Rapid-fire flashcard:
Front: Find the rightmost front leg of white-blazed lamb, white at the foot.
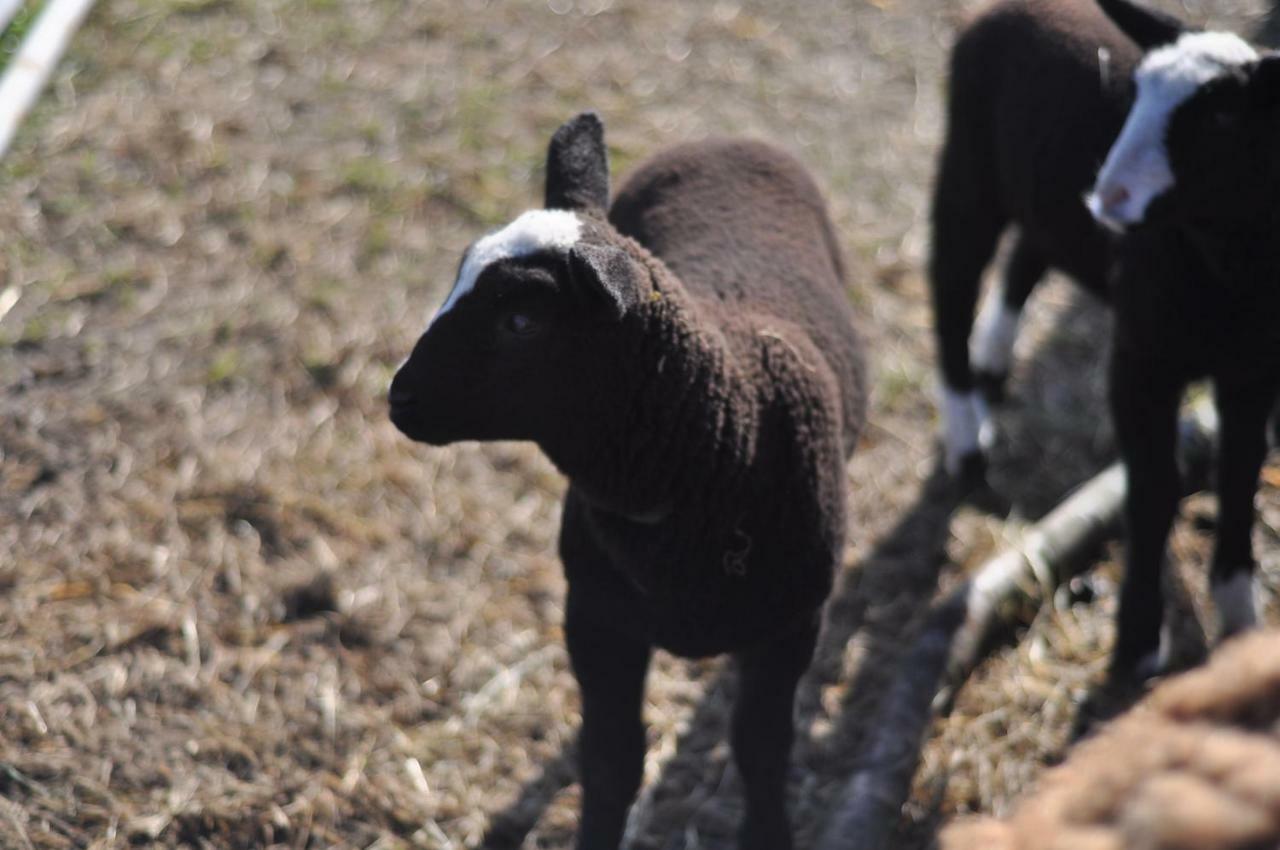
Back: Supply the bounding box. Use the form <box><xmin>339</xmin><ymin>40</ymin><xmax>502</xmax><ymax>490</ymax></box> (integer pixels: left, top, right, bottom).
<box><xmin>1210</xmin><ymin>381</ymin><xmax>1275</xmax><ymax>638</ymax></box>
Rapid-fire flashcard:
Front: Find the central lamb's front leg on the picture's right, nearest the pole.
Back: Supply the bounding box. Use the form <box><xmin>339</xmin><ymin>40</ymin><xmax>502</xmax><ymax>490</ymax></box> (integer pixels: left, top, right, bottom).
<box><xmin>732</xmin><ymin>614</ymin><xmax>818</xmax><ymax>850</ymax></box>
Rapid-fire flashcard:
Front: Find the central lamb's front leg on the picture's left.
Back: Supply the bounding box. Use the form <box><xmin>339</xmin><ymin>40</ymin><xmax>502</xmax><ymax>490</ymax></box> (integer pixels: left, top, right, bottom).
<box><xmin>564</xmin><ymin>596</ymin><xmax>652</xmax><ymax>850</ymax></box>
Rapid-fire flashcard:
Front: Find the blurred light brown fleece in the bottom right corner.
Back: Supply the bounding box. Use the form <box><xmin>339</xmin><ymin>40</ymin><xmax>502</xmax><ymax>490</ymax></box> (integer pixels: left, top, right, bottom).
<box><xmin>941</xmin><ymin>630</ymin><xmax>1280</xmax><ymax>850</ymax></box>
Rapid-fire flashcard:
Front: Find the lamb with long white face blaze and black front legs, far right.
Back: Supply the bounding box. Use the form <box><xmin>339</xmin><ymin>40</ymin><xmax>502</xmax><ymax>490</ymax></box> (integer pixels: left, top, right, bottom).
<box><xmin>1087</xmin><ymin>0</ymin><xmax>1280</xmax><ymax>675</ymax></box>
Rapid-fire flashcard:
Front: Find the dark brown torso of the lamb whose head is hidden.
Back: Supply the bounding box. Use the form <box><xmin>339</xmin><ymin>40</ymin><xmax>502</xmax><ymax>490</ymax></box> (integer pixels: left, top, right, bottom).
<box><xmin>934</xmin><ymin>0</ymin><xmax>1142</xmax><ymax>285</ymax></box>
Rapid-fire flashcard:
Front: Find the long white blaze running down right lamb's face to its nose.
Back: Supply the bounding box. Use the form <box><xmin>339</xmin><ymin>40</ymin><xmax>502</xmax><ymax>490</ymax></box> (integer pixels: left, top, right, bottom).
<box><xmin>1084</xmin><ymin>32</ymin><xmax>1258</xmax><ymax>232</ymax></box>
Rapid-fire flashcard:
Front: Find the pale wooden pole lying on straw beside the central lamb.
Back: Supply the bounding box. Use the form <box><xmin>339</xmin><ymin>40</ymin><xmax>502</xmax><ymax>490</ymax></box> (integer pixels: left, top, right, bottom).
<box><xmin>817</xmin><ymin>406</ymin><xmax>1216</xmax><ymax>850</ymax></box>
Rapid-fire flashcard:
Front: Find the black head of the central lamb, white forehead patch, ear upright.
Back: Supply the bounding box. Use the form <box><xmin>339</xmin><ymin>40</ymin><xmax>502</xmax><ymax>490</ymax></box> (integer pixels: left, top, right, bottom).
<box><xmin>389</xmin><ymin>114</ymin><xmax>652</xmax><ymax>445</ymax></box>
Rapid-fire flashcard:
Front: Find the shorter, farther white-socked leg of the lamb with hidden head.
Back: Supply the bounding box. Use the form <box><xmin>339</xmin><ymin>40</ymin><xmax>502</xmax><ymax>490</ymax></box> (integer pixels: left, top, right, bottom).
<box><xmin>969</xmin><ymin>232</ymin><xmax>1048</xmax><ymax>405</ymax></box>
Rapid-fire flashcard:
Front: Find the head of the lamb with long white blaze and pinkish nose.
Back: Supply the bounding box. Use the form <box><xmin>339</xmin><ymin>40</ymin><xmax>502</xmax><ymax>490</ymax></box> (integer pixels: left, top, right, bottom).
<box><xmin>1085</xmin><ymin>0</ymin><xmax>1280</xmax><ymax>232</ymax></box>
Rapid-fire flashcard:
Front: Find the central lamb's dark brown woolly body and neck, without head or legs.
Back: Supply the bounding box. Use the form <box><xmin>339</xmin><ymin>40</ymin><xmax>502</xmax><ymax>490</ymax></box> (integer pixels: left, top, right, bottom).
<box><xmin>563</xmin><ymin>141</ymin><xmax>867</xmax><ymax>655</ymax></box>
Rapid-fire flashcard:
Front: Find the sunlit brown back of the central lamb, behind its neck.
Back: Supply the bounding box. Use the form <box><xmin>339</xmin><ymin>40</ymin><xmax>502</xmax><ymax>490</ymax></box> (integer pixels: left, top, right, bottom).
<box><xmin>609</xmin><ymin>140</ymin><xmax>865</xmax><ymax>452</ymax></box>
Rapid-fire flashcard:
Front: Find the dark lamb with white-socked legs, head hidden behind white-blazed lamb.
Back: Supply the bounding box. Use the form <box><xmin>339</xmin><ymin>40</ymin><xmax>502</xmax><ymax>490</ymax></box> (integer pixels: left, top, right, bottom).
<box><xmin>929</xmin><ymin>0</ymin><xmax>1142</xmax><ymax>483</ymax></box>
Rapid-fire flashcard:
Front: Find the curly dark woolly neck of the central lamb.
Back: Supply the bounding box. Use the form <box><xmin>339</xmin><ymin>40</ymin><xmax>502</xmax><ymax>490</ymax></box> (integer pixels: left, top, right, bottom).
<box><xmin>548</xmin><ymin>268</ymin><xmax>758</xmax><ymax>522</ymax></box>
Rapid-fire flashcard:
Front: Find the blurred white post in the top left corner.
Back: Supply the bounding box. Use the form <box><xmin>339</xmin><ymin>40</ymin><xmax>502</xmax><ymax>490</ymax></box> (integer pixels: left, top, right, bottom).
<box><xmin>0</xmin><ymin>0</ymin><xmax>93</xmax><ymax>156</ymax></box>
